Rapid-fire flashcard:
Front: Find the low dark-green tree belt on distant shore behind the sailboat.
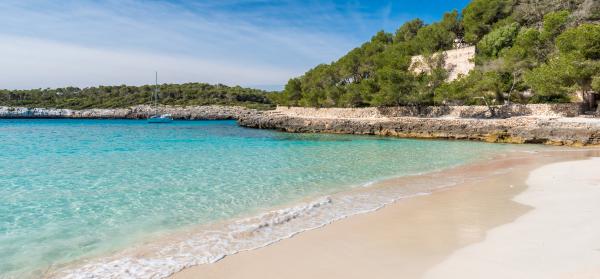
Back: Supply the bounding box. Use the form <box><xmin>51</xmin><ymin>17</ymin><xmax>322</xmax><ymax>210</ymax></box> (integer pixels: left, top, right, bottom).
<box><xmin>0</xmin><ymin>83</ymin><xmax>273</xmax><ymax>109</ymax></box>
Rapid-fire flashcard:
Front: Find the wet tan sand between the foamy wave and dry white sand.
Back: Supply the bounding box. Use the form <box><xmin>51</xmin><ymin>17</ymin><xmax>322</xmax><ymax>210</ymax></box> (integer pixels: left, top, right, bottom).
<box><xmin>170</xmin><ymin>149</ymin><xmax>600</xmax><ymax>279</ymax></box>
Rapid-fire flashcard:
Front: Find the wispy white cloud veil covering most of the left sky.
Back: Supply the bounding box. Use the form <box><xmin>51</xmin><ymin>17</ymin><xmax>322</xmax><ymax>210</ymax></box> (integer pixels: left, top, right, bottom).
<box><xmin>0</xmin><ymin>0</ymin><xmax>364</xmax><ymax>88</ymax></box>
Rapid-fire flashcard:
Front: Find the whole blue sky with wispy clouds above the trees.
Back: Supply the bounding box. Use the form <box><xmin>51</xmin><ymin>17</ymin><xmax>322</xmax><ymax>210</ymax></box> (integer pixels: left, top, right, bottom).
<box><xmin>0</xmin><ymin>0</ymin><xmax>469</xmax><ymax>90</ymax></box>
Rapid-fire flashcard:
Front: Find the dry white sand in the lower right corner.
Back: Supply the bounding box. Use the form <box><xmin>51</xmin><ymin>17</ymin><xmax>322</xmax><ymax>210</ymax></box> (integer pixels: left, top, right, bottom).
<box><xmin>425</xmin><ymin>158</ymin><xmax>600</xmax><ymax>278</ymax></box>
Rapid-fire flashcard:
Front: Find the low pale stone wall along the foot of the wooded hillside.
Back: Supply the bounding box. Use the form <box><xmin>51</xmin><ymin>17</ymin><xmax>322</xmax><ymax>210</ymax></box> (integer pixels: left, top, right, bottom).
<box><xmin>275</xmin><ymin>103</ymin><xmax>582</xmax><ymax>118</ymax></box>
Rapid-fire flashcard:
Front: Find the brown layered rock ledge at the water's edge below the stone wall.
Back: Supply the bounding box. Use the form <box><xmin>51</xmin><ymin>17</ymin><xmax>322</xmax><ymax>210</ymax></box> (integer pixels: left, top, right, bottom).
<box><xmin>238</xmin><ymin>112</ymin><xmax>600</xmax><ymax>146</ymax></box>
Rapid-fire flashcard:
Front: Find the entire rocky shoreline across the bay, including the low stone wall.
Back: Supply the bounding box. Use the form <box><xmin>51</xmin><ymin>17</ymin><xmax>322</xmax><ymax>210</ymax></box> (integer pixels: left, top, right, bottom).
<box><xmin>0</xmin><ymin>105</ymin><xmax>600</xmax><ymax>146</ymax></box>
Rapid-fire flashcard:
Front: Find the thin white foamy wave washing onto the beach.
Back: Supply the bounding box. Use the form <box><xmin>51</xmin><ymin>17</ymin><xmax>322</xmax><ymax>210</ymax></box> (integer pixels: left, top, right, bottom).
<box><xmin>48</xmin><ymin>174</ymin><xmax>455</xmax><ymax>279</ymax></box>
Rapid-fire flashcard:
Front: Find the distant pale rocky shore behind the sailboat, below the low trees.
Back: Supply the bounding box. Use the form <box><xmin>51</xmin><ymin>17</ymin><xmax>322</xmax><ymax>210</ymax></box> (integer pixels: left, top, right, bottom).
<box><xmin>0</xmin><ymin>105</ymin><xmax>257</xmax><ymax>120</ymax></box>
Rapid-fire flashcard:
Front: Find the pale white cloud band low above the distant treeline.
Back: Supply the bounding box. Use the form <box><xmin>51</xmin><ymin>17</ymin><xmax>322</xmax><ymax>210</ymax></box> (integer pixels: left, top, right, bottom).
<box><xmin>0</xmin><ymin>36</ymin><xmax>299</xmax><ymax>88</ymax></box>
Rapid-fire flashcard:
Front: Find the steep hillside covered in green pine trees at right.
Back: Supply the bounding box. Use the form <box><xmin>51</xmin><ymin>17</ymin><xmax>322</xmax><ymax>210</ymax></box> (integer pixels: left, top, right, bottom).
<box><xmin>276</xmin><ymin>0</ymin><xmax>600</xmax><ymax>109</ymax></box>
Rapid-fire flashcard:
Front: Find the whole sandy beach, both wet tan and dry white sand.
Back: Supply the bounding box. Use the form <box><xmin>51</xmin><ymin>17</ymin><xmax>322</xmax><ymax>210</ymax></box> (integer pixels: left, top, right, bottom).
<box><xmin>172</xmin><ymin>150</ymin><xmax>600</xmax><ymax>279</ymax></box>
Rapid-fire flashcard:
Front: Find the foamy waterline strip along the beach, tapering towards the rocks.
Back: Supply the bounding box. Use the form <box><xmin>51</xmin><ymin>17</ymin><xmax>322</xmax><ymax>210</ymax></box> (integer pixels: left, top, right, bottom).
<box><xmin>45</xmin><ymin>148</ymin><xmax>510</xmax><ymax>278</ymax></box>
